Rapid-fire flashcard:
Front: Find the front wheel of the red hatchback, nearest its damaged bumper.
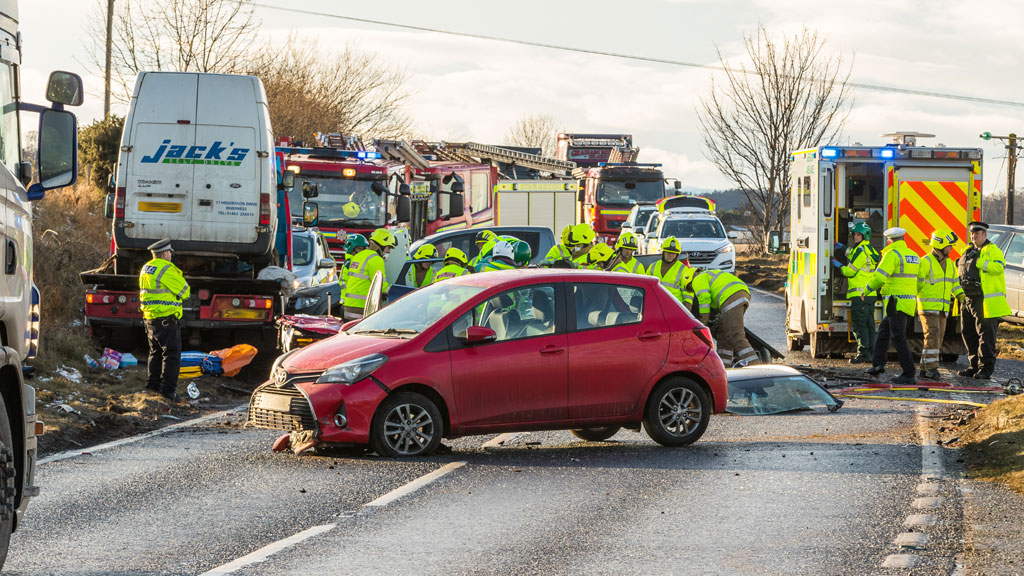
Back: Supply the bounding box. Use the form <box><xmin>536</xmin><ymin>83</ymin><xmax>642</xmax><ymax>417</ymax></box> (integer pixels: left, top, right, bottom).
<box><xmin>370</xmin><ymin>392</ymin><xmax>444</xmax><ymax>457</ymax></box>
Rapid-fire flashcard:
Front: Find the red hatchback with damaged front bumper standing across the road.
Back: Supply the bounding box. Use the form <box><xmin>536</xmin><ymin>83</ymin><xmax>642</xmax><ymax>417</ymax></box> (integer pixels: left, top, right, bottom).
<box><xmin>249</xmin><ymin>270</ymin><xmax>728</xmax><ymax>456</ymax></box>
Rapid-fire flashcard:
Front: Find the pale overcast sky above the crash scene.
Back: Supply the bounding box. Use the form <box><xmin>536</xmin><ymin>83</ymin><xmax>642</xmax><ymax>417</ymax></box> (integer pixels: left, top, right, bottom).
<box><xmin>20</xmin><ymin>0</ymin><xmax>1024</xmax><ymax>193</ymax></box>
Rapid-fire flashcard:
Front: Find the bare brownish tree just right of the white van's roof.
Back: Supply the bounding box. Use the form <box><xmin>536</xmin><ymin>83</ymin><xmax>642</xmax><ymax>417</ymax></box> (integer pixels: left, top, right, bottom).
<box><xmin>254</xmin><ymin>35</ymin><xmax>411</xmax><ymax>141</ymax></box>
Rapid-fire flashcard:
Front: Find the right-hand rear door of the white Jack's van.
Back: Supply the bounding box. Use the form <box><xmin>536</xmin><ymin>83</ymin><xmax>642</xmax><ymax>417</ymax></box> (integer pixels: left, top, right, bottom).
<box><xmin>191</xmin><ymin>76</ymin><xmax>261</xmax><ymax>244</ymax></box>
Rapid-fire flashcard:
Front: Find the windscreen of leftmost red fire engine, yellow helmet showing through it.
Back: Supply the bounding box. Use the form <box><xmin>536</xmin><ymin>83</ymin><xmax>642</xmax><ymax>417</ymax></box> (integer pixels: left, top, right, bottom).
<box><xmin>288</xmin><ymin>175</ymin><xmax>387</xmax><ymax>227</ymax></box>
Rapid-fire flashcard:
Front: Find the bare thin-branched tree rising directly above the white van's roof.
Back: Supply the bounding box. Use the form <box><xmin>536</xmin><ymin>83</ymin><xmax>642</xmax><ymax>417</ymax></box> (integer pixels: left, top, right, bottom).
<box><xmin>88</xmin><ymin>0</ymin><xmax>259</xmax><ymax>101</ymax></box>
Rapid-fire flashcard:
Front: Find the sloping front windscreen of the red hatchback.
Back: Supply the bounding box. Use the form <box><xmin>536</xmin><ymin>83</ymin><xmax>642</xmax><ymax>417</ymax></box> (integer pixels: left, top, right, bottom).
<box><xmin>349</xmin><ymin>280</ymin><xmax>483</xmax><ymax>336</ymax></box>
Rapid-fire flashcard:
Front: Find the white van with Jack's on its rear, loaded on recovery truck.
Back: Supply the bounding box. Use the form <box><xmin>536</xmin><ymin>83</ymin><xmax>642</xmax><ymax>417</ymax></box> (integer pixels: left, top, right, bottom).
<box><xmin>114</xmin><ymin>72</ymin><xmax>278</xmax><ymax>265</ymax></box>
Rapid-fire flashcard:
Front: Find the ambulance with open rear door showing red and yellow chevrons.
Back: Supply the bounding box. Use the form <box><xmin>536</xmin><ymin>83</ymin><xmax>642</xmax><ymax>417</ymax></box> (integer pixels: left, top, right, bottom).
<box><xmin>768</xmin><ymin>132</ymin><xmax>982</xmax><ymax>361</ymax></box>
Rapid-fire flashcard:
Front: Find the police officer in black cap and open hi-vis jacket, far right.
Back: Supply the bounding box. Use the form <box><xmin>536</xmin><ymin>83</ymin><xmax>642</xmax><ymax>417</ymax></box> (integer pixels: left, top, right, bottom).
<box><xmin>957</xmin><ymin>221</ymin><xmax>1013</xmax><ymax>379</ymax></box>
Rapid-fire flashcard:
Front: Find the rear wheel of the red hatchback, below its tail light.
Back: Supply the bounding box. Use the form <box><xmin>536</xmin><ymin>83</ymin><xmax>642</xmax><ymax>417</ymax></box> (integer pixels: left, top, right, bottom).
<box><xmin>643</xmin><ymin>376</ymin><xmax>712</xmax><ymax>446</ymax></box>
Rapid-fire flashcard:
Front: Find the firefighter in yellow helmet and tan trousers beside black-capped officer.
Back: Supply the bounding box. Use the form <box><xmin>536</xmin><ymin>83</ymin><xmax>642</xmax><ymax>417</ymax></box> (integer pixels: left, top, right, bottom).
<box><xmin>918</xmin><ymin>228</ymin><xmax>964</xmax><ymax>380</ymax></box>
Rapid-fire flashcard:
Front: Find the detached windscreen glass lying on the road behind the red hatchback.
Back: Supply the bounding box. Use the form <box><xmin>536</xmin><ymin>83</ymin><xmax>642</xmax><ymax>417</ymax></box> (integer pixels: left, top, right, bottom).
<box><xmin>725</xmin><ymin>374</ymin><xmax>843</xmax><ymax>415</ymax></box>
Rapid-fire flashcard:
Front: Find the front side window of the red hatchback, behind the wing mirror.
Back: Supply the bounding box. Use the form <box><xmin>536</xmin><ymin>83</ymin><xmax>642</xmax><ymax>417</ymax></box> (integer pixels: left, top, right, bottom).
<box><xmin>452</xmin><ymin>284</ymin><xmax>555</xmax><ymax>342</ymax></box>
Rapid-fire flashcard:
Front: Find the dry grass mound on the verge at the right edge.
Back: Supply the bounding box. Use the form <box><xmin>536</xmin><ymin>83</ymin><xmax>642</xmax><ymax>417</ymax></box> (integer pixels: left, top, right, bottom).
<box><xmin>961</xmin><ymin>396</ymin><xmax>1024</xmax><ymax>494</ymax></box>
